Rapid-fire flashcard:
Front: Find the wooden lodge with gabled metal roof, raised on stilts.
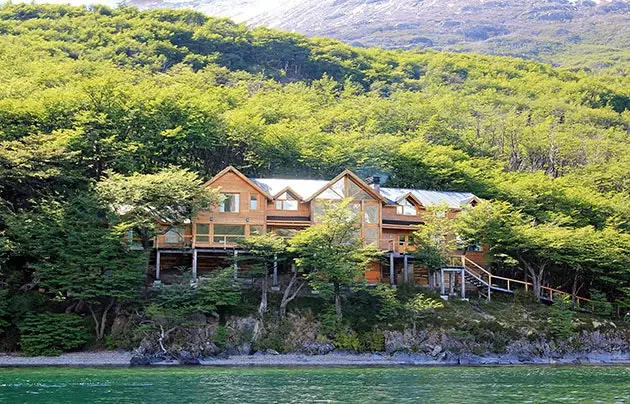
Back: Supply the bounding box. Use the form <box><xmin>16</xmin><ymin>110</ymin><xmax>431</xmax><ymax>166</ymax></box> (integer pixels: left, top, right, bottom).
<box><xmin>152</xmin><ymin>167</ymin><xmax>486</xmax><ymax>286</ymax></box>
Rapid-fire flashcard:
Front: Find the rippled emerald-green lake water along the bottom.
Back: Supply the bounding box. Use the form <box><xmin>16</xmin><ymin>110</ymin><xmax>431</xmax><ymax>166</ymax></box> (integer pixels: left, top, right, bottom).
<box><xmin>0</xmin><ymin>366</ymin><xmax>630</xmax><ymax>404</ymax></box>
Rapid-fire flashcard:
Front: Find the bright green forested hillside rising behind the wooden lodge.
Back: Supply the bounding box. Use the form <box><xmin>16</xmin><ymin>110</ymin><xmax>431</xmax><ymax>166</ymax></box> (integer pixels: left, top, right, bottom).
<box><xmin>0</xmin><ymin>5</ymin><xmax>630</xmax><ymax>350</ymax></box>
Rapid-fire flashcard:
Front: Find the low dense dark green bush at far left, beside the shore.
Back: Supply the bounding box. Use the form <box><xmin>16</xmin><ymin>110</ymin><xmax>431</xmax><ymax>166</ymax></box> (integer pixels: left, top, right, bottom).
<box><xmin>19</xmin><ymin>313</ymin><xmax>90</xmax><ymax>356</ymax></box>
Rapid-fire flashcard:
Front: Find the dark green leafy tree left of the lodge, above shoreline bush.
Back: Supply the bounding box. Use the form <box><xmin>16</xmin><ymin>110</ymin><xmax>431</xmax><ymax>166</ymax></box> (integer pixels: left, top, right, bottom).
<box><xmin>8</xmin><ymin>194</ymin><xmax>147</xmax><ymax>339</ymax></box>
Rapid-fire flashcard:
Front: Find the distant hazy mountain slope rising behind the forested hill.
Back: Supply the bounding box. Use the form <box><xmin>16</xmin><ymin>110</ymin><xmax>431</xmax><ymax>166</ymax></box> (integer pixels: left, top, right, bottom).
<box><xmin>130</xmin><ymin>0</ymin><xmax>630</xmax><ymax>67</ymax></box>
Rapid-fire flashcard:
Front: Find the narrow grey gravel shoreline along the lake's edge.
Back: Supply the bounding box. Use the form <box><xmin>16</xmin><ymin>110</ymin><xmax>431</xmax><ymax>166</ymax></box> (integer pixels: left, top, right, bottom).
<box><xmin>0</xmin><ymin>351</ymin><xmax>630</xmax><ymax>368</ymax></box>
